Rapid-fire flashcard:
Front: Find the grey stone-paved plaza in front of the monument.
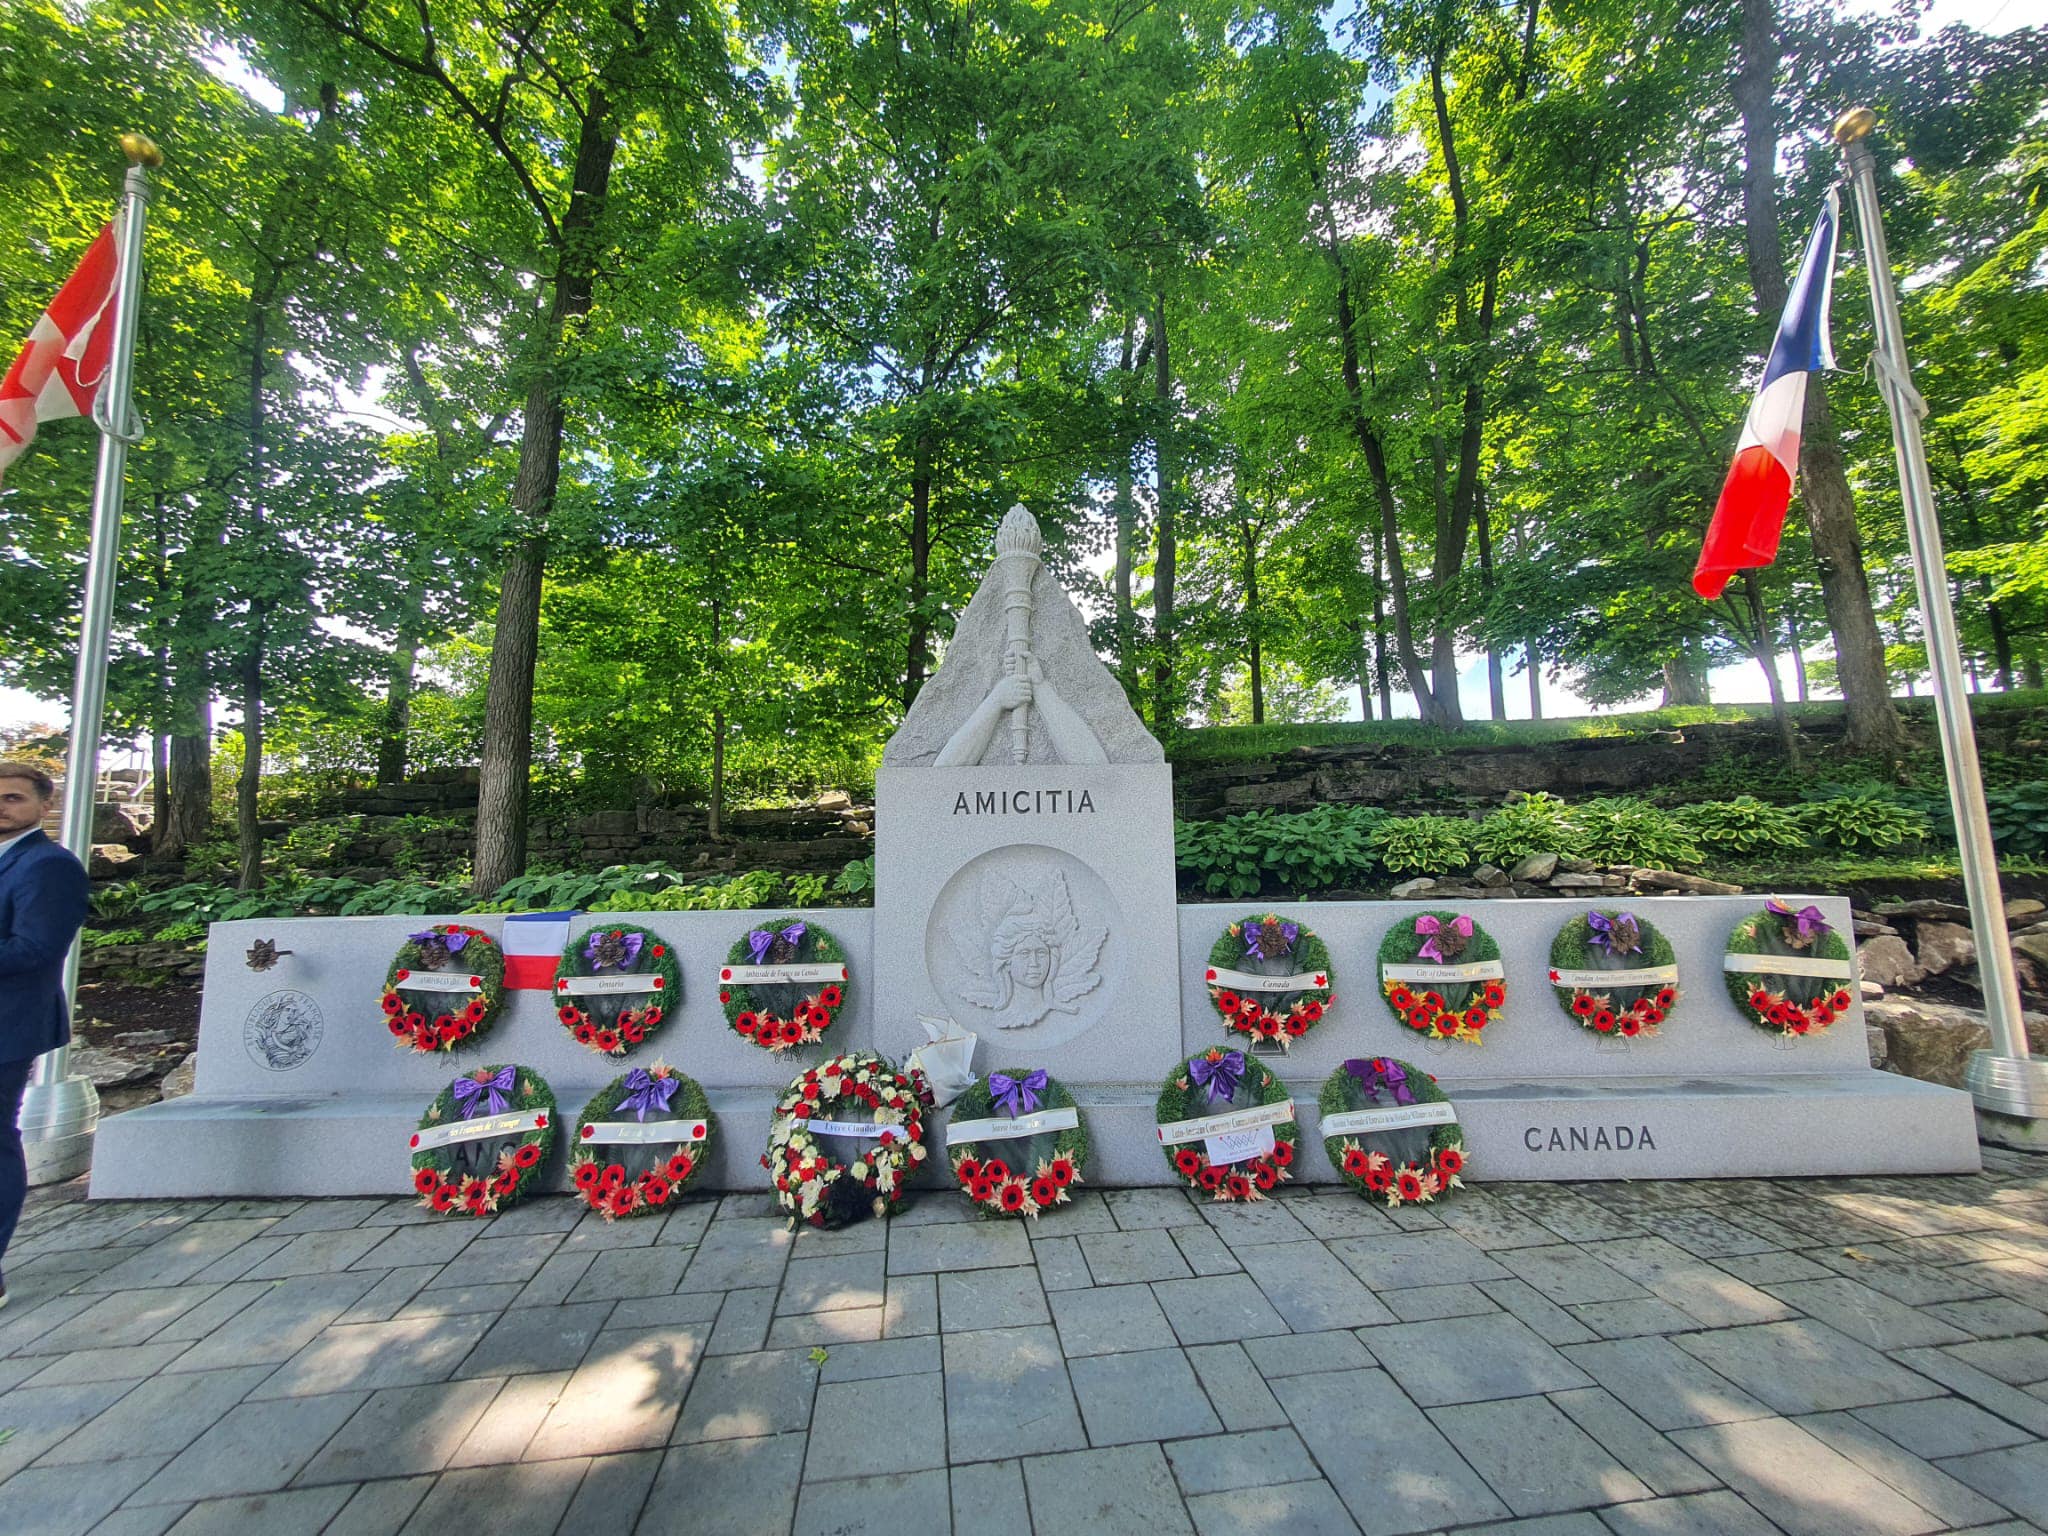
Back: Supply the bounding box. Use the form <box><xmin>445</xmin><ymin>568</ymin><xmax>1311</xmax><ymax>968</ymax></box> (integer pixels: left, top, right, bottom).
<box><xmin>0</xmin><ymin>1149</ymin><xmax>2048</xmax><ymax>1536</ymax></box>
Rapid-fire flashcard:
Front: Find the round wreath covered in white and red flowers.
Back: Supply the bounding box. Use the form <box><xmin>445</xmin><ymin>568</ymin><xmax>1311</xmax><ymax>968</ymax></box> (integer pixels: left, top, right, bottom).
<box><xmin>762</xmin><ymin>1051</ymin><xmax>926</xmax><ymax>1227</ymax></box>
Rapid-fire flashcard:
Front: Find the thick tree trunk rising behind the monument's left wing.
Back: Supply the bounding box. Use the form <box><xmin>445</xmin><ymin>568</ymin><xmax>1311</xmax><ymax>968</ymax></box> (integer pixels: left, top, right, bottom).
<box><xmin>471</xmin><ymin>108</ymin><xmax>618</xmax><ymax>897</ymax></box>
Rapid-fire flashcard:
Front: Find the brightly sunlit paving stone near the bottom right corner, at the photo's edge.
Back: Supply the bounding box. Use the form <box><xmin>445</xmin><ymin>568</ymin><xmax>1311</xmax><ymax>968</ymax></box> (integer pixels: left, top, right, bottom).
<box><xmin>1671</xmin><ymin>1419</ymin><xmax>1944</xmax><ymax>1536</ymax></box>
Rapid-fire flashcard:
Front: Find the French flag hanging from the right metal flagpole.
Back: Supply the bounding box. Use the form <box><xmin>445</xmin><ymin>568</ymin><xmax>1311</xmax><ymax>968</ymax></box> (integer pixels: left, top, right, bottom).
<box><xmin>1692</xmin><ymin>190</ymin><xmax>1841</xmax><ymax>602</ymax></box>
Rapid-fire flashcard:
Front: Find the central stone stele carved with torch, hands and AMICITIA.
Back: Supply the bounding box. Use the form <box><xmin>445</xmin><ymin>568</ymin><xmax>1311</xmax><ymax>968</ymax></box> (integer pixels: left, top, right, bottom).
<box><xmin>872</xmin><ymin>506</ymin><xmax>1180</xmax><ymax>1083</ymax></box>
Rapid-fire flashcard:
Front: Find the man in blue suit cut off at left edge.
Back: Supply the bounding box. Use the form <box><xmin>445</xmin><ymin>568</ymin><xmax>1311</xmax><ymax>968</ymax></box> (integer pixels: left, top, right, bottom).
<box><xmin>0</xmin><ymin>762</ymin><xmax>90</xmax><ymax>1307</ymax></box>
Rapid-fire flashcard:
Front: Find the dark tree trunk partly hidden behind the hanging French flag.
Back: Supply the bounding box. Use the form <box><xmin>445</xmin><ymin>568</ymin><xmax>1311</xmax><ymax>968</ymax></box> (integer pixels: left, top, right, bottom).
<box><xmin>1735</xmin><ymin>0</ymin><xmax>1907</xmax><ymax>760</ymax></box>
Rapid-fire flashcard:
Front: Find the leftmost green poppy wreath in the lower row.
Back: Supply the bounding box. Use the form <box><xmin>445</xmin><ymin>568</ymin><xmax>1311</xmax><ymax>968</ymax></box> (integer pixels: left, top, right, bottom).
<box><xmin>412</xmin><ymin>1063</ymin><xmax>555</xmax><ymax>1217</ymax></box>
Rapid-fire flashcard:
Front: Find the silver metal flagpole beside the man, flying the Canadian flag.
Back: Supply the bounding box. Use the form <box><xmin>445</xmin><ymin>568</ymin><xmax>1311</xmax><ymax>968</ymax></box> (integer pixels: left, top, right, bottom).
<box><xmin>20</xmin><ymin>133</ymin><xmax>164</xmax><ymax>1184</ymax></box>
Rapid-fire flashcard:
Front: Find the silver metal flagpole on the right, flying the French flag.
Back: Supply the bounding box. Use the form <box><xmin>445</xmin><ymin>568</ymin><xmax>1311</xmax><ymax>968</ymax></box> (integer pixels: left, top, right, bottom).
<box><xmin>1835</xmin><ymin>106</ymin><xmax>2048</xmax><ymax>1145</ymax></box>
